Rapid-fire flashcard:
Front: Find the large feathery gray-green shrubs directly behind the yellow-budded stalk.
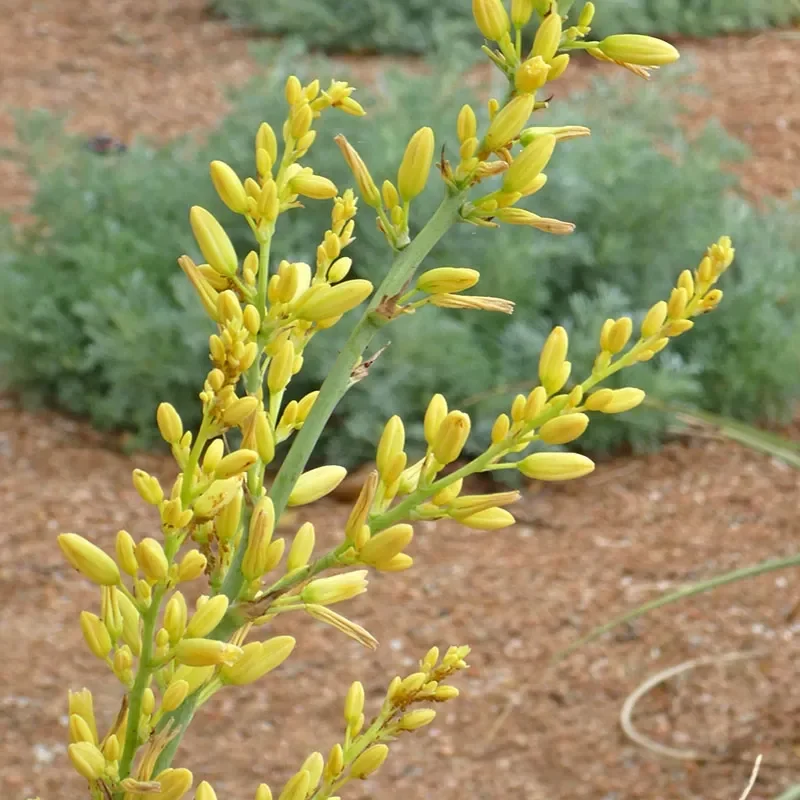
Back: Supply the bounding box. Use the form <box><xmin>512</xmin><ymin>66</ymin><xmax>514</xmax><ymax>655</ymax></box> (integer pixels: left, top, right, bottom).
<box><xmin>0</xmin><ymin>47</ymin><xmax>800</xmax><ymax>463</ymax></box>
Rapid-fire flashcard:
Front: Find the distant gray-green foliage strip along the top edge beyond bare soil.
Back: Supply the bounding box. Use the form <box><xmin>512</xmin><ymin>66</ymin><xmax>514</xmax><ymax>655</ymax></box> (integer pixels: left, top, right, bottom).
<box><xmin>212</xmin><ymin>0</ymin><xmax>800</xmax><ymax>53</ymax></box>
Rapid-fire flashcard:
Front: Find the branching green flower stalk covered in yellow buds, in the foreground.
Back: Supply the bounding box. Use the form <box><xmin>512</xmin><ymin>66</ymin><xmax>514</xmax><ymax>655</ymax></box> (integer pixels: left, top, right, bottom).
<box><xmin>39</xmin><ymin>0</ymin><xmax>733</xmax><ymax>800</ymax></box>
